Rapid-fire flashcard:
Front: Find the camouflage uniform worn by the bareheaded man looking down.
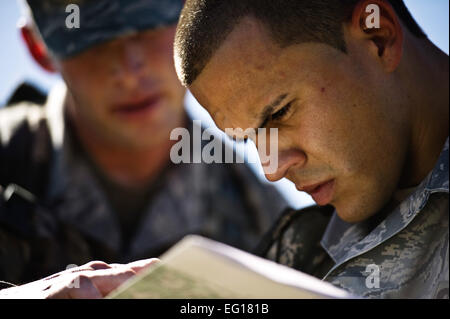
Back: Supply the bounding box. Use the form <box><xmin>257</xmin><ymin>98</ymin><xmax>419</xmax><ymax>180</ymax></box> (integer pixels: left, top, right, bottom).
<box><xmin>258</xmin><ymin>139</ymin><xmax>449</xmax><ymax>298</ymax></box>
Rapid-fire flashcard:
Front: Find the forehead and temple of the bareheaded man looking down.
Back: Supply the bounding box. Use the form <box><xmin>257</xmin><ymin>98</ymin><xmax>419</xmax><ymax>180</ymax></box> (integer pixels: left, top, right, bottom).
<box><xmin>191</xmin><ymin>18</ymin><xmax>346</xmax><ymax>134</ymax></box>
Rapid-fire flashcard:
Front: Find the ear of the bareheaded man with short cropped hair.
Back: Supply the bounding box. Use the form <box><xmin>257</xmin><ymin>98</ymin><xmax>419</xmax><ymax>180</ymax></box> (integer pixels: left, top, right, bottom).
<box><xmin>350</xmin><ymin>0</ymin><xmax>403</xmax><ymax>72</ymax></box>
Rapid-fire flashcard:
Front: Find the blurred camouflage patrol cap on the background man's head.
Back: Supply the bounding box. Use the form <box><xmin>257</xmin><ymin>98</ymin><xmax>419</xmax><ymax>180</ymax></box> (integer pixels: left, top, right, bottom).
<box><xmin>26</xmin><ymin>0</ymin><xmax>184</xmax><ymax>59</ymax></box>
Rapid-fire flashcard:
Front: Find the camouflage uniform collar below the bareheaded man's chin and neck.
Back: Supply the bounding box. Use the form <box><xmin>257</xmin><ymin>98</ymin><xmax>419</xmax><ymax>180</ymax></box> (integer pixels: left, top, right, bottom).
<box><xmin>321</xmin><ymin>138</ymin><xmax>449</xmax><ymax>268</ymax></box>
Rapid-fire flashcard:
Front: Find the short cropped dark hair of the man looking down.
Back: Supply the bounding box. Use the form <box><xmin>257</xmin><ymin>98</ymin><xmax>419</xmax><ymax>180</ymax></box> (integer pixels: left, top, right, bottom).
<box><xmin>175</xmin><ymin>0</ymin><xmax>426</xmax><ymax>86</ymax></box>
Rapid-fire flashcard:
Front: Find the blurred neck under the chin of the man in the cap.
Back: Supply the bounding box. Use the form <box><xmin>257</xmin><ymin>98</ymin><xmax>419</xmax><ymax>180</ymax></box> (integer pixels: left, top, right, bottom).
<box><xmin>66</xmin><ymin>97</ymin><xmax>184</xmax><ymax>188</ymax></box>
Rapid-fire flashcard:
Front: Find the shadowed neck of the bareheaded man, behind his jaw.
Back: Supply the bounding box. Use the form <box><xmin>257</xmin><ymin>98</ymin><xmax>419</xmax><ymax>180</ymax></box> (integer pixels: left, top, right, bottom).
<box><xmin>399</xmin><ymin>38</ymin><xmax>449</xmax><ymax>188</ymax></box>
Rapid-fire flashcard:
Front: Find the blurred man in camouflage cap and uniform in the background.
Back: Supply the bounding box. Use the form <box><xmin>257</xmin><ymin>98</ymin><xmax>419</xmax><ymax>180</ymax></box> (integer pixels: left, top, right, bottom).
<box><xmin>0</xmin><ymin>0</ymin><xmax>285</xmax><ymax>298</ymax></box>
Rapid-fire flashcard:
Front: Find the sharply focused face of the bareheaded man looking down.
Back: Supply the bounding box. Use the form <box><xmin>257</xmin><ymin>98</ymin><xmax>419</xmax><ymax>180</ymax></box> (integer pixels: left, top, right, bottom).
<box><xmin>190</xmin><ymin>19</ymin><xmax>407</xmax><ymax>222</ymax></box>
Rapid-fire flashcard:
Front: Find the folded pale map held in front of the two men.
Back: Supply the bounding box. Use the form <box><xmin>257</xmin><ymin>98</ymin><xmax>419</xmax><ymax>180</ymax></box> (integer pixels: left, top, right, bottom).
<box><xmin>107</xmin><ymin>235</ymin><xmax>352</xmax><ymax>299</ymax></box>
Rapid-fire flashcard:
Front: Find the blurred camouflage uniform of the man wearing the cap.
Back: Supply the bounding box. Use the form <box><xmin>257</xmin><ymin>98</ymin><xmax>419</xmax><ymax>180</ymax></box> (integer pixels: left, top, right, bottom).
<box><xmin>0</xmin><ymin>85</ymin><xmax>286</xmax><ymax>283</ymax></box>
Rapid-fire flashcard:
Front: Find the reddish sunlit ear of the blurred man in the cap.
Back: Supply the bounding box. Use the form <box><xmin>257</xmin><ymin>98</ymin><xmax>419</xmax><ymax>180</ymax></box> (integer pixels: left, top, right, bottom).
<box><xmin>19</xmin><ymin>24</ymin><xmax>56</xmax><ymax>73</ymax></box>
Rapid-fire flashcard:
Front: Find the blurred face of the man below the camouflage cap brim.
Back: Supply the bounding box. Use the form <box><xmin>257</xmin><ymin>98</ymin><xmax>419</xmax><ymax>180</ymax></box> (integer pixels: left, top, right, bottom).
<box><xmin>57</xmin><ymin>26</ymin><xmax>185</xmax><ymax>147</ymax></box>
